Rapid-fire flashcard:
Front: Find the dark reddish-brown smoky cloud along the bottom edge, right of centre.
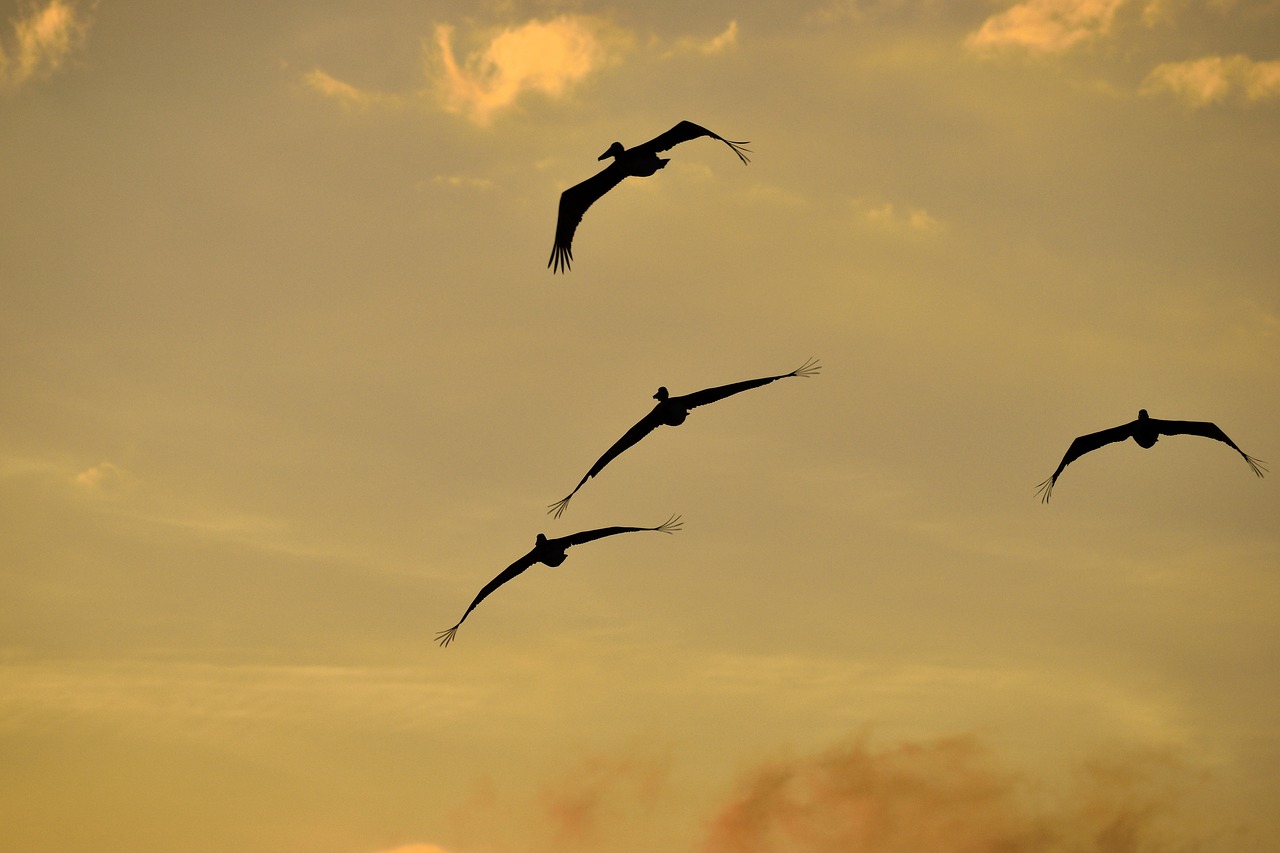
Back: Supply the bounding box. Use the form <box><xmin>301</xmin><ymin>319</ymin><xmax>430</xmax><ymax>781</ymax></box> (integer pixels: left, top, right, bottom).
<box><xmin>703</xmin><ymin>738</ymin><xmax>1194</xmax><ymax>853</ymax></box>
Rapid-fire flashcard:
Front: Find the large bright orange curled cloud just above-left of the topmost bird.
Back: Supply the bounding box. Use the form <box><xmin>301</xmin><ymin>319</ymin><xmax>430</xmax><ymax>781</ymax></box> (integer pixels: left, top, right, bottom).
<box><xmin>435</xmin><ymin>15</ymin><xmax>608</xmax><ymax>124</ymax></box>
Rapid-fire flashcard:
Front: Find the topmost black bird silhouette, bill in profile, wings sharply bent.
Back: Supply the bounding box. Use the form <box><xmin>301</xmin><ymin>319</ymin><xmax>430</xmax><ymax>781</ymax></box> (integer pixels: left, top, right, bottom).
<box><xmin>547</xmin><ymin>122</ymin><xmax>750</xmax><ymax>273</ymax></box>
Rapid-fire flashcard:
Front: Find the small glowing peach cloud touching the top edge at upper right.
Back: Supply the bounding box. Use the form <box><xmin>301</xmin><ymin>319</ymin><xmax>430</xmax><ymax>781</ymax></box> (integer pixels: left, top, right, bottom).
<box><xmin>965</xmin><ymin>0</ymin><xmax>1125</xmax><ymax>54</ymax></box>
